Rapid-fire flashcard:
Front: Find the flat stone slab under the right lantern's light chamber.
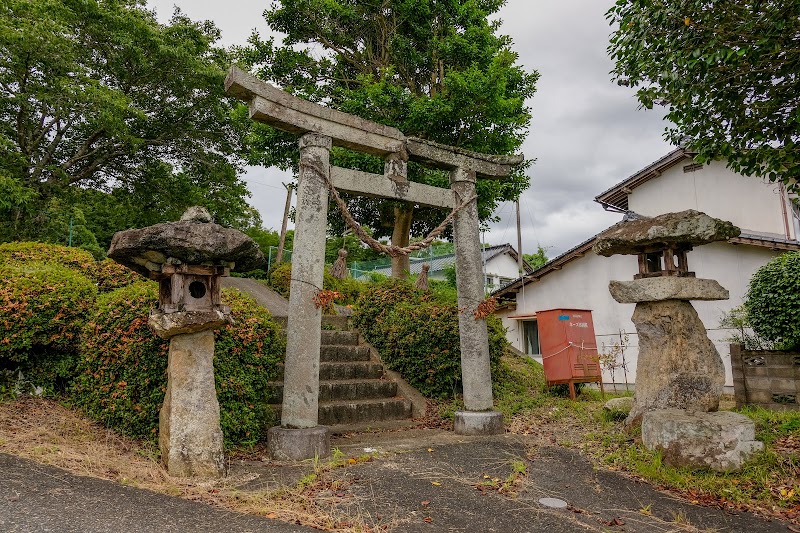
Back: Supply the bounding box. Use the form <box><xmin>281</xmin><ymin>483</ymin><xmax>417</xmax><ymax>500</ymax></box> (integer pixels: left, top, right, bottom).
<box><xmin>608</xmin><ymin>276</ymin><xmax>730</xmax><ymax>304</ymax></box>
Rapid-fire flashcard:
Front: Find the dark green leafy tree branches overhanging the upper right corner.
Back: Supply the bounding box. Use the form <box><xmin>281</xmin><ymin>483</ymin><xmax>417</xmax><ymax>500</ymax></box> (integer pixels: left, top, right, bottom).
<box><xmin>607</xmin><ymin>0</ymin><xmax>800</xmax><ymax>190</ymax></box>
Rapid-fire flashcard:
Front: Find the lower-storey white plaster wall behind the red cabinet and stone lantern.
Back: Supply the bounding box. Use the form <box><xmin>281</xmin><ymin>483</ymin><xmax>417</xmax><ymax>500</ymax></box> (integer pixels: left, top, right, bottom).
<box><xmin>510</xmin><ymin>243</ymin><xmax>777</xmax><ymax>386</ymax></box>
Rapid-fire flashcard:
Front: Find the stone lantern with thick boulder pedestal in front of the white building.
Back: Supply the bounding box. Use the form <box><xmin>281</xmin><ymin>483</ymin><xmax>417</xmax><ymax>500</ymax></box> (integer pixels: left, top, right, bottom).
<box><xmin>594</xmin><ymin>210</ymin><xmax>740</xmax><ymax>423</ymax></box>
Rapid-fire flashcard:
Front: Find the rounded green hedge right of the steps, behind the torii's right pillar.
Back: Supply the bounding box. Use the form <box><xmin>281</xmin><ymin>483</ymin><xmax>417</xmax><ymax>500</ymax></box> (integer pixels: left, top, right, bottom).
<box><xmin>353</xmin><ymin>279</ymin><xmax>508</xmax><ymax>398</ymax></box>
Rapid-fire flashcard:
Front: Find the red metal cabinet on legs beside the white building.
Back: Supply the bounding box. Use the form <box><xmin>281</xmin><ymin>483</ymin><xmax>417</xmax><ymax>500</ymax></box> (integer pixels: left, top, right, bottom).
<box><xmin>536</xmin><ymin>309</ymin><xmax>603</xmax><ymax>398</ymax></box>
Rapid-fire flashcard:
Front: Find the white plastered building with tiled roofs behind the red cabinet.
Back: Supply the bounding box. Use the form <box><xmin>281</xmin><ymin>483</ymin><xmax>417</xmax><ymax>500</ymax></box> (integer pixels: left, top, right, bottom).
<box><xmin>494</xmin><ymin>148</ymin><xmax>800</xmax><ymax>385</ymax></box>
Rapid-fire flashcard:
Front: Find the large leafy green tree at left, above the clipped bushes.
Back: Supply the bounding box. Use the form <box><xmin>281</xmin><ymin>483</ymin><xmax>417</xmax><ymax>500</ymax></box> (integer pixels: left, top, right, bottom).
<box><xmin>0</xmin><ymin>0</ymin><xmax>257</xmax><ymax>244</ymax></box>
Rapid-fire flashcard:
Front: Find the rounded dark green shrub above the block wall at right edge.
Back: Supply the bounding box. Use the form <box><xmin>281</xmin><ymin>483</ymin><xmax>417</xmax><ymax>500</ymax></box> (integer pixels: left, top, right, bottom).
<box><xmin>744</xmin><ymin>252</ymin><xmax>800</xmax><ymax>350</ymax></box>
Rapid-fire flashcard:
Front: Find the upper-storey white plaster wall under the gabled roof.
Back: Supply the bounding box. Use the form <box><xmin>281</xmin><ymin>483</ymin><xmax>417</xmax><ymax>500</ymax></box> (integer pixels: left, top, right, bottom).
<box><xmin>628</xmin><ymin>159</ymin><xmax>797</xmax><ymax>239</ymax></box>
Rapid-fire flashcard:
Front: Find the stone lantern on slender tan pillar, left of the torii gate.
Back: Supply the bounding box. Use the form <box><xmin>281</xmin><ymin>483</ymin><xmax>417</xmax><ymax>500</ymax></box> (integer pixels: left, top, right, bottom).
<box><xmin>108</xmin><ymin>207</ymin><xmax>264</xmax><ymax>477</ymax></box>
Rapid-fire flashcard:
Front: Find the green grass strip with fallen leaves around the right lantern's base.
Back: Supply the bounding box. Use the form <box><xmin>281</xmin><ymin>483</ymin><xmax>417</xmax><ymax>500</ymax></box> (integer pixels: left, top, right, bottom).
<box><xmin>496</xmin><ymin>390</ymin><xmax>800</xmax><ymax>523</ymax></box>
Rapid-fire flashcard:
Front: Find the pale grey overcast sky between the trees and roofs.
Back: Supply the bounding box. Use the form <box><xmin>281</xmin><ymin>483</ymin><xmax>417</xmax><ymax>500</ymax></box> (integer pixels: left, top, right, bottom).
<box><xmin>148</xmin><ymin>0</ymin><xmax>672</xmax><ymax>258</ymax></box>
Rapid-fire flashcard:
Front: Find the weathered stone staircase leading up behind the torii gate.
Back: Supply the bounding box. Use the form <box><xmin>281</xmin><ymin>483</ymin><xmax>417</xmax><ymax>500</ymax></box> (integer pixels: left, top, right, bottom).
<box><xmin>268</xmin><ymin>330</ymin><xmax>424</xmax><ymax>433</ymax></box>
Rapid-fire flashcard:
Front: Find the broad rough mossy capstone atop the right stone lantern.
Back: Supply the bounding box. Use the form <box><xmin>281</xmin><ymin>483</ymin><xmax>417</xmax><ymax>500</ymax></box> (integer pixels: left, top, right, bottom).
<box><xmin>592</xmin><ymin>209</ymin><xmax>741</xmax><ymax>257</ymax></box>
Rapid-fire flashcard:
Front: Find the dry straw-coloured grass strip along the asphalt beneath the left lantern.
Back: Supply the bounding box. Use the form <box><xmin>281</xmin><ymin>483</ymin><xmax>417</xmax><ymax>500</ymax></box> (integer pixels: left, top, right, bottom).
<box><xmin>0</xmin><ymin>398</ymin><xmax>382</xmax><ymax>533</ymax></box>
